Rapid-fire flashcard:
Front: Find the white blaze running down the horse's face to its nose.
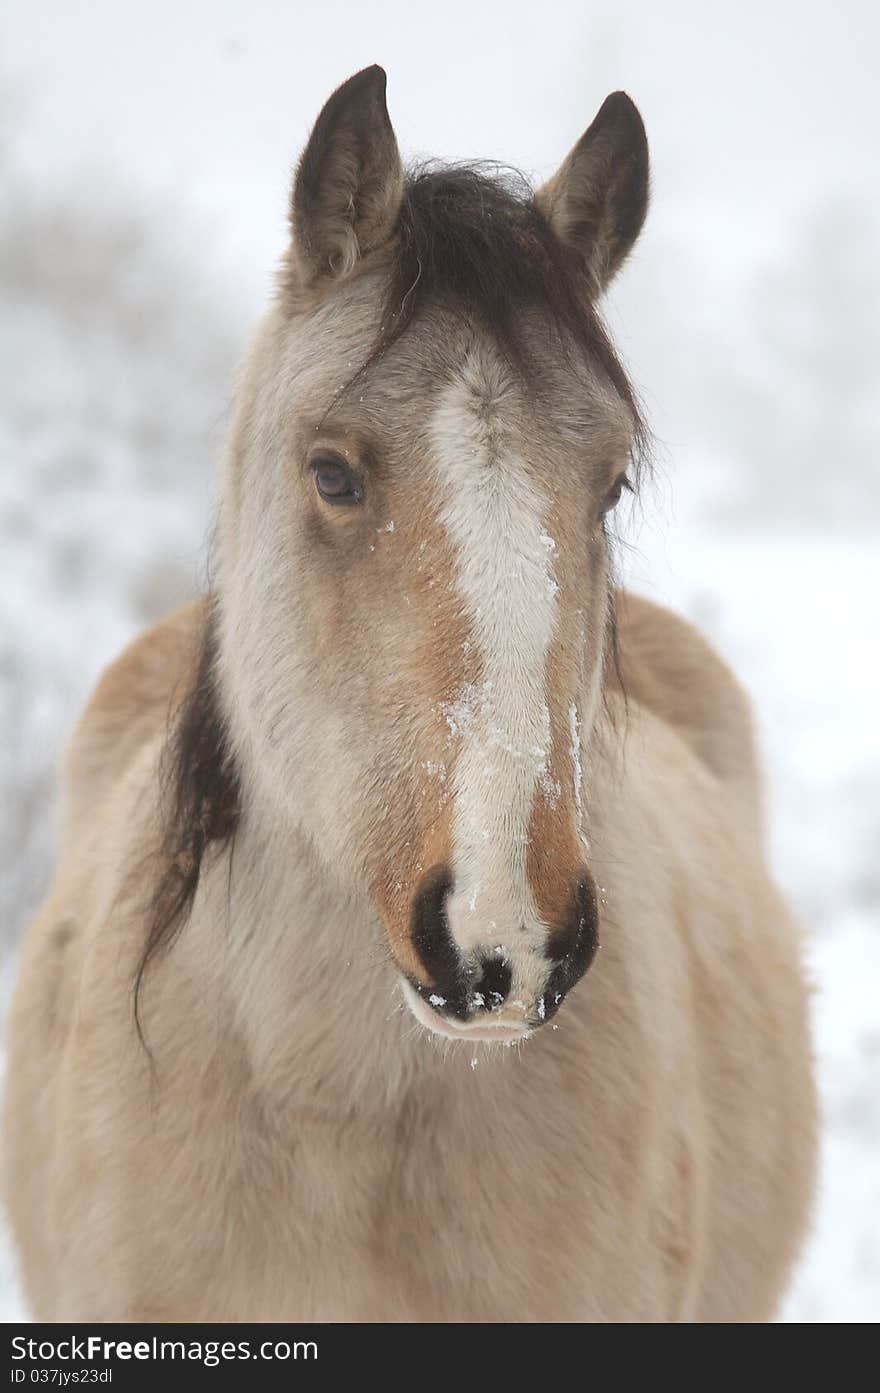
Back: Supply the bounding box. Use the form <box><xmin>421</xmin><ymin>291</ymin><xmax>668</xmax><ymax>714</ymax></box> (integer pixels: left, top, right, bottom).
<box><xmin>432</xmin><ymin>382</ymin><xmax>558</xmax><ymax>949</ymax></box>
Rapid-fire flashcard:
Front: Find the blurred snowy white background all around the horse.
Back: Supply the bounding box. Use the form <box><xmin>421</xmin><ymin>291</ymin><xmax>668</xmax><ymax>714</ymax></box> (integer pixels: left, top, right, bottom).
<box><xmin>0</xmin><ymin>0</ymin><xmax>880</xmax><ymax>1322</ymax></box>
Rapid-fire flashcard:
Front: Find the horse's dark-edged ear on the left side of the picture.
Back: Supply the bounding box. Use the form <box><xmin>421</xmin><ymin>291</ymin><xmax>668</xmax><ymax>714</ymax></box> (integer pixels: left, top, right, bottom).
<box><xmin>291</xmin><ymin>67</ymin><xmax>404</xmax><ymax>281</ymax></box>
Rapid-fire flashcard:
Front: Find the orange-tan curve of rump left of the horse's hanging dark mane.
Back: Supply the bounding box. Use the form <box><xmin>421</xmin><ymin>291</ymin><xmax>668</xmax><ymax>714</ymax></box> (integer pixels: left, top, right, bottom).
<box><xmin>61</xmin><ymin>599</ymin><xmax>205</xmax><ymax>847</ymax></box>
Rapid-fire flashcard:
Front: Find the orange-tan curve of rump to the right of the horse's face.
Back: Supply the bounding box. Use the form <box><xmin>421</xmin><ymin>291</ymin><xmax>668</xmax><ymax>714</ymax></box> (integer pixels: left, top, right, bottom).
<box><xmin>611</xmin><ymin>591</ymin><xmax>762</xmax><ymax>840</ymax></box>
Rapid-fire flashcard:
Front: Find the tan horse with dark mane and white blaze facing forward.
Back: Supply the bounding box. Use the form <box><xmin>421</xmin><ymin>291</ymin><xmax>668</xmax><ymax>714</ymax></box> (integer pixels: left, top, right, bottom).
<box><xmin>4</xmin><ymin>67</ymin><xmax>816</xmax><ymax>1322</ymax></box>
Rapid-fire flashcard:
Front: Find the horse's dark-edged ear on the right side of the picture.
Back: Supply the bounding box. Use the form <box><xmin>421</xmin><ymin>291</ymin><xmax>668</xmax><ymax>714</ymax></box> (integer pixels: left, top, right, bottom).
<box><xmin>535</xmin><ymin>92</ymin><xmax>649</xmax><ymax>295</ymax></box>
